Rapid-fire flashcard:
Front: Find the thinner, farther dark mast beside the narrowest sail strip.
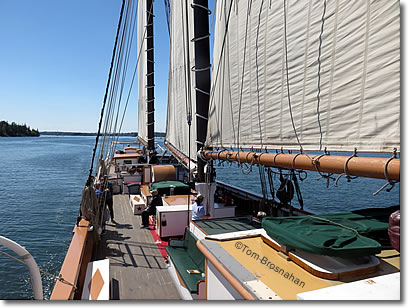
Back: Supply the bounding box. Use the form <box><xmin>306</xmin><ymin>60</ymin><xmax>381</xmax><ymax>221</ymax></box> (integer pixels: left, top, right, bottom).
<box><xmin>146</xmin><ymin>0</ymin><xmax>154</xmax><ymax>157</ymax></box>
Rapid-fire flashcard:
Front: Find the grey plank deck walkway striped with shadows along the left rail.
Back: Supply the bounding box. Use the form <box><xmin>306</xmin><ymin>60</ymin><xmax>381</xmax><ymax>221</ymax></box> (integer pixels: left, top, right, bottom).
<box><xmin>95</xmin><ymin>195</ymin><xmax>180</xmax><ymax>300</ymax></box>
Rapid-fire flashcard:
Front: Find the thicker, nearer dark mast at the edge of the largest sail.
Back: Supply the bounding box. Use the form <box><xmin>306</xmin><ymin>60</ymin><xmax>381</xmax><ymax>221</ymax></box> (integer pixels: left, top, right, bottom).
<box><xmin>192</xmin><ymin>0</ymin><xmax>211</xmax><ymax>182</ymax></box>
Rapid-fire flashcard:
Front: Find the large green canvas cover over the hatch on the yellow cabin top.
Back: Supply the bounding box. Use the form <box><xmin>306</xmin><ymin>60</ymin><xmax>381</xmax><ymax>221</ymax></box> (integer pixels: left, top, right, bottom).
<box><xmin>262</xmin><ymin>207</ymin><xmax>395</xmax><ymax>258</ymax></box>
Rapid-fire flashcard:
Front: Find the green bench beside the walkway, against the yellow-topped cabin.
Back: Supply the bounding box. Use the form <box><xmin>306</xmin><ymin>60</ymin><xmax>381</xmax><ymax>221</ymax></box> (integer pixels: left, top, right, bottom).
<box><xmin>166</xmin><ymin>230</ymin><xmax>205</xmax><ymax>293</ymax></box>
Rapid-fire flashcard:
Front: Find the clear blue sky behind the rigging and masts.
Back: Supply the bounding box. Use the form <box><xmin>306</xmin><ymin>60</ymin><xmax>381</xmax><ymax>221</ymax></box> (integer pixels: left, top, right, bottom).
<box><xmin>0</xmin><ymin>0</ymin><xmax>190</xmax><ymax>132</ymax></box>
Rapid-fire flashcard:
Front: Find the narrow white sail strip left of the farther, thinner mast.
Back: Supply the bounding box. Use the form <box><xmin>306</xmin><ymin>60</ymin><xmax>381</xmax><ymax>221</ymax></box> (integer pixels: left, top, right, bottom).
<box><xmin>137</xmin><ymin>1</ymin><xmax>147</xmax><ymax>141</ymax></box>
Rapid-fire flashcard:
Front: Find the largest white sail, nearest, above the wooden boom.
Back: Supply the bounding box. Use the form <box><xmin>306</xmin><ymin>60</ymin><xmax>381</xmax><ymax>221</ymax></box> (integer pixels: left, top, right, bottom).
<box><xmin>206</xmin><ymin>0</ymin><xmax>400</xmax><ymax>152</ymax></box>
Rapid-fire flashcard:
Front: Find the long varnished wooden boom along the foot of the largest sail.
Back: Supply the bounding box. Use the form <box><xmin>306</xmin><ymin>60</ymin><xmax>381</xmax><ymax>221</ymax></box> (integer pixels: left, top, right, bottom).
<box><xmin>202</xmin><ymin>150</ymin><xmax>400</xmax><ymax>182</ymax></box>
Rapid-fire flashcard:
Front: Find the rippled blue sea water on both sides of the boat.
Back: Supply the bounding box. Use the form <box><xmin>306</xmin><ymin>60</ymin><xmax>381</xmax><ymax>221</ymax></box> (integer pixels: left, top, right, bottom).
<box><xmin>0</xmin><ymin>136</ymin><xmax>400</xmax><ymax>299</ymax></box>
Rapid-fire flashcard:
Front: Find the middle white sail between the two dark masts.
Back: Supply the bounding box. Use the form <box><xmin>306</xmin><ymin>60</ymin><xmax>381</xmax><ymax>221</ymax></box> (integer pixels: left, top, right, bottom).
<box><xmin>166</xmin><ymin>0</ymin><xmax>197</xmax><ymax>160</ymax></box>
